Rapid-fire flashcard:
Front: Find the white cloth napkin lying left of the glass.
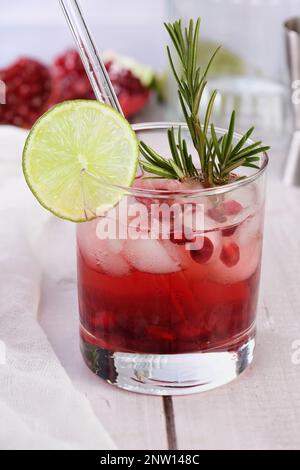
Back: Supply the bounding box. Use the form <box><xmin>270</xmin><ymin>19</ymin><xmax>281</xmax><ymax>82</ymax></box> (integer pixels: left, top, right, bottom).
<box><xmin>0</xmin><ymin>126</ymin><xmax>115</xmax><ymax>450</ymax></box>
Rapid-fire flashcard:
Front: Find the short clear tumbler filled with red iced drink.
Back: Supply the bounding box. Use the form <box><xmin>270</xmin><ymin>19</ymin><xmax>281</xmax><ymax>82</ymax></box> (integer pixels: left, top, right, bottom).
<box><xmin>77</xmin><ymin>123</ymin><xmax>268</xmax><ymax>395</ymax></box>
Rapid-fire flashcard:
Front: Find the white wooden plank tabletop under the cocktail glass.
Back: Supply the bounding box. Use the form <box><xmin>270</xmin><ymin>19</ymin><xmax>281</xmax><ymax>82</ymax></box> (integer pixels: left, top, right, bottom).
<box><xmin>40</xmin><ymin>171</ymin><xmax>300</xmax><ymax>450</ymax></box>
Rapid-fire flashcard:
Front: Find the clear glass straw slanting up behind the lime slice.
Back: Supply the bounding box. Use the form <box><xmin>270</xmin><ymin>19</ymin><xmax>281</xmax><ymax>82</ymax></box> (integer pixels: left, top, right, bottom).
<box><xmin>59</xmin><ymin>0</ymin><xmax>123</xmax><ymax>114</ymax></box>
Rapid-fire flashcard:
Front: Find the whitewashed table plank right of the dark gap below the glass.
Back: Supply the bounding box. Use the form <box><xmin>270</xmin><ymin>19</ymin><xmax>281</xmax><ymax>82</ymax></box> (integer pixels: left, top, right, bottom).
<box><xmin>173</xmin><ymin>183</ymin><xmax>300</xmax><ymax>449</ymax></box>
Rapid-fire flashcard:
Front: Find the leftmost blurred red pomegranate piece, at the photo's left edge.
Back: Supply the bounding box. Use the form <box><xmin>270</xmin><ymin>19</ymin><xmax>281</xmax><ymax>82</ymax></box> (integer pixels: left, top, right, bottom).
<box><xmin>0</xmin><ymin>57</ymin><xmax>52</xmax><ymax>128</ymax></box>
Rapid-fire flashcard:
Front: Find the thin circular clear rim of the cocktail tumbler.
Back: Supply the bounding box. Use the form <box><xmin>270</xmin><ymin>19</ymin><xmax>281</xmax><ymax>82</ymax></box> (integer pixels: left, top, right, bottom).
<box><xmin>86</xmin><ymin>122</ymin><xmax>269</xmax><ymax>198</ymax></box>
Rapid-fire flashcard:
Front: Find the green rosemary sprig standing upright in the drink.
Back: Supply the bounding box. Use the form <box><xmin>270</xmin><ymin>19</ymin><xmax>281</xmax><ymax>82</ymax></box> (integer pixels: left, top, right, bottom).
<box><xmin>141</xmin><ymin>18</ymin><xmax>270</xmax><ymax>186</ymax></box>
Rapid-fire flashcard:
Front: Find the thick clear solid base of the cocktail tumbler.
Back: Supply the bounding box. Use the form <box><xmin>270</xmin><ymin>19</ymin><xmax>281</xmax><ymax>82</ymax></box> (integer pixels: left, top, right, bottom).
<box><xmin>81</xmin><ymin>332</ymin><xmax>255</xmax><ymax>396</ymax></box>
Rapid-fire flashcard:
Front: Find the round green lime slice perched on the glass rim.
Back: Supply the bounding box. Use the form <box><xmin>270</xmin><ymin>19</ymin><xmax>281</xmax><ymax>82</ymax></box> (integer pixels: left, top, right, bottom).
<box><xmin>23</xmin><ymin>100</ymin><xmax>139</xmax><ymax>222</ymax></box>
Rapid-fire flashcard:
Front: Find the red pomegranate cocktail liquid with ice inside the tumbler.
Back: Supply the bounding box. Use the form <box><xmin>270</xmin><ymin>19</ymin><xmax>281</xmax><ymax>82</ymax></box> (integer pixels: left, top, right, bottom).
<box><xmin>78</xmin><ymin>185</ymin><xmax>262</xmax><ymax>354</ymax></box>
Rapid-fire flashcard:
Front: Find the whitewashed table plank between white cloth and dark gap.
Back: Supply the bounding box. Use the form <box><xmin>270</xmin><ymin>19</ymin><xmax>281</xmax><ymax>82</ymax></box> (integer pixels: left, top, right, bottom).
<box><xmin>40</xmin><ymin>221</ymin><xmax>168</xmax><ymax>450</ymax></box>
